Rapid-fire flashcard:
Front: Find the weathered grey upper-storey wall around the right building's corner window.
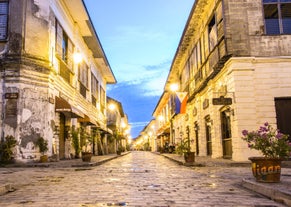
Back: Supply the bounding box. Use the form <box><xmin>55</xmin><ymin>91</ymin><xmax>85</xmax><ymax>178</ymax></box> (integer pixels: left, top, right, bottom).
<box><xmin>223</xmin><ymin>0</ymin><xmax>291</xmax><ymax>57</ymax></box>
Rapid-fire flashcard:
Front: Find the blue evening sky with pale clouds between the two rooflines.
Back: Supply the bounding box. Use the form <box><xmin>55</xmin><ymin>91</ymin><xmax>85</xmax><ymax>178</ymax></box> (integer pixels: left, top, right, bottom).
<box><xmin>85</xmin><ymin>0</ymin><xmax>194</xmax><ymax>138</ymax></box>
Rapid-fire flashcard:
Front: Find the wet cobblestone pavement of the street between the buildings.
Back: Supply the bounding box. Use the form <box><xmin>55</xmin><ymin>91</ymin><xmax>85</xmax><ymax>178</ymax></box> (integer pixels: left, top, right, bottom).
<box><xmin>0</xmin><ymin>152</ymin><xmax>283</xmax><ymax>207</ymax></box>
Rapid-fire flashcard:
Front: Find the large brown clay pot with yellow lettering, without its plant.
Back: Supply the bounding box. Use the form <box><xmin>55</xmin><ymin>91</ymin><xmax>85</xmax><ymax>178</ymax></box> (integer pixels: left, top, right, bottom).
<box><xmin>249</xmin><ymin>157</ymin><xmax>282</xmax><ymax>183</ymax></box>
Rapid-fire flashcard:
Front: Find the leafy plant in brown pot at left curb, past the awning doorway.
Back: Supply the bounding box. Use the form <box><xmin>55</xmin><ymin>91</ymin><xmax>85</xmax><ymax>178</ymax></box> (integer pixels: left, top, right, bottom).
<box><xmin>80</xmin><ymin>128</ymin><xmax>93</xmax><ymax>162</ymax></box>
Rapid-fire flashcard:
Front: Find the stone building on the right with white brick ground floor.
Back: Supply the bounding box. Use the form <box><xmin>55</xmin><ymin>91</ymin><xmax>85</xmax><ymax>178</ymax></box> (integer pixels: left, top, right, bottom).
<box><xmin>156</xmin><ymin>0</ymin><xmax>291</xmax><ymax>161</ymax></box>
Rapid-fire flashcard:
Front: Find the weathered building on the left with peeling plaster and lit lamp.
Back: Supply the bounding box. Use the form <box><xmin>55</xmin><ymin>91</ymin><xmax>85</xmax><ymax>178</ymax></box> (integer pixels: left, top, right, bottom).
<box><xmin>0</xmin><ymin>0</ymin><xmax>116</xmax><ymax>161</ymax></box>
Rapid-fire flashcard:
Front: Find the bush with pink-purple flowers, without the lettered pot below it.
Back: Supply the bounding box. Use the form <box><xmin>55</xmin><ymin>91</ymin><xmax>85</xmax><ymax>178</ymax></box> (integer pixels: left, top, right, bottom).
<box><xmin>242</xmin><ymin>122</ymin><xmax>291</xmax><ymax>158</ymax></box>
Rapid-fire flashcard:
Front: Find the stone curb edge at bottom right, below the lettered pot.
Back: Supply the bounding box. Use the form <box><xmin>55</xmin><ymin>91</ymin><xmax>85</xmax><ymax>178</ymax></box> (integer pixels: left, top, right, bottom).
<box><xmin>241</xmin><ymin>179</ymin><xmax>291</xmax><ymax>206</ymax></box>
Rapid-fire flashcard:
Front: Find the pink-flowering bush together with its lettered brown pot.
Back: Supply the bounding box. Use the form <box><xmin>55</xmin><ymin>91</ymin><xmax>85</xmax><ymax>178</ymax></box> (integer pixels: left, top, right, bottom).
<box><xmin>242</xmin><ymin>122</ymin><xmax>291</xmax><ymax>182</ymax></box>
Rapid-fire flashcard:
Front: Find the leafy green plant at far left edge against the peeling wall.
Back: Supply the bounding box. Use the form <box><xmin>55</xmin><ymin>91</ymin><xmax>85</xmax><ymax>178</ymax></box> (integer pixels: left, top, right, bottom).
<box><xmin>0</xmin><ymin>135</ymin><xmax>17</xmax><ymax>163</ymax></box>
